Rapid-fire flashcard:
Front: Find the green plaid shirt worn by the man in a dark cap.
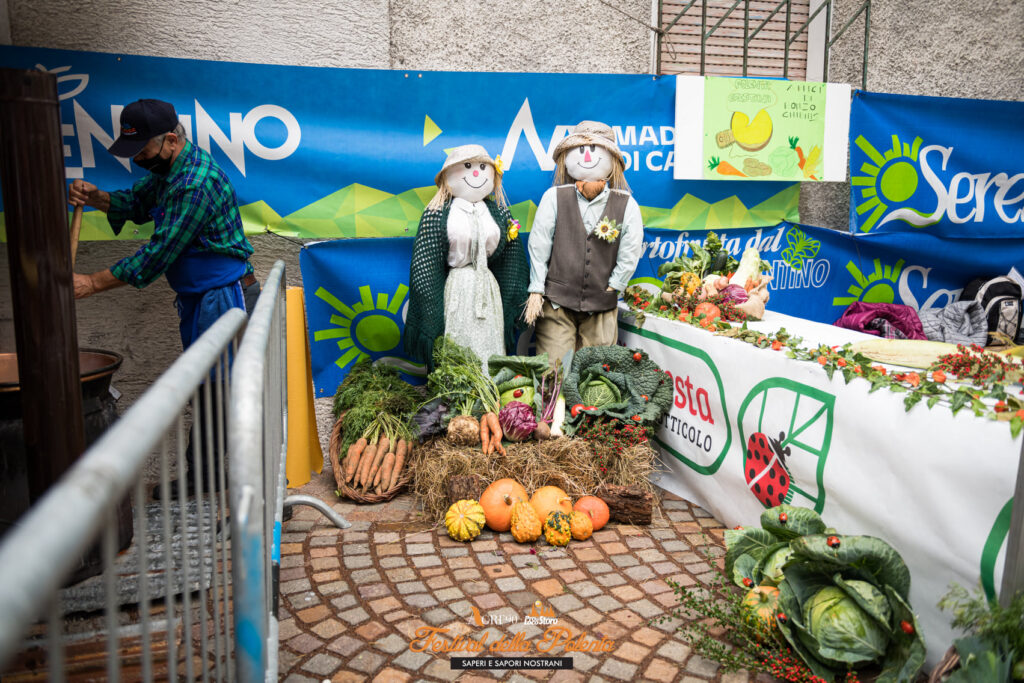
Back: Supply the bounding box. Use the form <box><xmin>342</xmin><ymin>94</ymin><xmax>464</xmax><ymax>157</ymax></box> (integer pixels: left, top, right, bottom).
<box><xmin>106</xmin><ymin>142</ymin><xmax>253</xmax><ymax>288</ymax></box>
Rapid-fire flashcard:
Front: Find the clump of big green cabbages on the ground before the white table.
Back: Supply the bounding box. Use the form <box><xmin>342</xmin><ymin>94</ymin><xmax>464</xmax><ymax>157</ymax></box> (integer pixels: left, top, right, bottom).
<box><xmin>725</xmin><ymin>505</ymin><xmax>925</xmax><ymax>683</ymax></box>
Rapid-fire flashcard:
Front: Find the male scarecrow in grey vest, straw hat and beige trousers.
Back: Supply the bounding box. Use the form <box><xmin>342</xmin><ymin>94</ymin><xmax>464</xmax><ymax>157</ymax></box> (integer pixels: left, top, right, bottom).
<box><xmin>524</xmin><ymin>121</ymin><xmax>643</xmax><ymax>364</ymax></box>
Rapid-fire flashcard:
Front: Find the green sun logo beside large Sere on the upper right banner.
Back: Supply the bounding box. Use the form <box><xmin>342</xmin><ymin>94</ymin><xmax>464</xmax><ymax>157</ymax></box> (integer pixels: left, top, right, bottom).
<box><xmin>850</xmin><ymin>135</ymin><xmax>926</xmax><ymax>232</ymax></box>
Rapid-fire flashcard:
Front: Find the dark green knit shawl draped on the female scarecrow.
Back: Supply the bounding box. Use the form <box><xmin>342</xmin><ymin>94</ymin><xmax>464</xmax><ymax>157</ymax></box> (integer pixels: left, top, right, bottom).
<box><xmin>402</xmin><ymin>199</ymin><xmax>529</xmax><ymax>368</ymax></box>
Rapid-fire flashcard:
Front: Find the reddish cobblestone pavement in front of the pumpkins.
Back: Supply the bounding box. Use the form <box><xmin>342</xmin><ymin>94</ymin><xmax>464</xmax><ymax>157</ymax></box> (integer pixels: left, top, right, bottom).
<box><xmin>280</xmin><ymin>483</ymin><xmax>760</xmax><ymax>683</ymax></box>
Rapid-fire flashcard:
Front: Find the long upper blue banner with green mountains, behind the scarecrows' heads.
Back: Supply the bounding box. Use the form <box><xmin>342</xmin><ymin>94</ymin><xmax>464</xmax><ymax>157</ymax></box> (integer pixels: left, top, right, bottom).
<box><xmin>0</xmin><ymin>47</ymin><xmax>800</xmax><ymax>239</ymax></box>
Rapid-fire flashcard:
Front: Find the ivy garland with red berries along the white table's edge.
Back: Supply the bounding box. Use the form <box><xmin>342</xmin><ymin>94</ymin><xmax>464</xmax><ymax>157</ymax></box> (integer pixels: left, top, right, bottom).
<box><xmin>625</xmin><ymin>287</ymin><xmax>1024</xmax><ymax>438</ymax></box>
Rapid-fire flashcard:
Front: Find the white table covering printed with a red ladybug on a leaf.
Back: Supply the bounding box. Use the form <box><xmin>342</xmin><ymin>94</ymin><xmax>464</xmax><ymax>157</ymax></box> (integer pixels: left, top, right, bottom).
<box><xmin>618</xmin><ymin>304</ymin><xmax>1020</xmax><ymax>666</ymax></box>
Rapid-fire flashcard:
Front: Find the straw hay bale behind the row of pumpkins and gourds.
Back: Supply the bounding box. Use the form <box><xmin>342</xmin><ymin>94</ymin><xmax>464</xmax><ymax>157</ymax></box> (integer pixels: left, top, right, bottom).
<box><xmin>413</xmin><ymin>438</ymin><xmax>656</xmax><ymax>520</ymax></box>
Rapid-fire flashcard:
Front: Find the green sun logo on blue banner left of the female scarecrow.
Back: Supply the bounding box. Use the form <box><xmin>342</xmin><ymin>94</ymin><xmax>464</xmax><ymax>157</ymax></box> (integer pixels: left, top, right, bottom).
<box><xmin>313</xmin><ymin>285</ymin><xmax>409</xmax><ymax>370</ymax></box>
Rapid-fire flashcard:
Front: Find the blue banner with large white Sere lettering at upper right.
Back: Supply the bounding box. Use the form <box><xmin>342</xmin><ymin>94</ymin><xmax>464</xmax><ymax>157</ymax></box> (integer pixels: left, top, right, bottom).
<box><xmin>850</xmin><ymin>91</ymin><xmax>1024</xmax><ymax>239</ymax></box>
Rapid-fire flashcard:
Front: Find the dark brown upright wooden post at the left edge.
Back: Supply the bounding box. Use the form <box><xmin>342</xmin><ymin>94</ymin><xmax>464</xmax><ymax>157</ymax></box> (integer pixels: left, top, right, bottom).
<box><xmin>0</xmin><ymin>69</ymin><xmax>85</xmax><ymax>501</ymax></box>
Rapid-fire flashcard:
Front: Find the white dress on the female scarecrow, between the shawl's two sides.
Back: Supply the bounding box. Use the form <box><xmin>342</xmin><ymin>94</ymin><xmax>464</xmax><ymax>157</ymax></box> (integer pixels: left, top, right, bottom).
<box><xmin>444</xmin><ymin>197</ymin><xmax>505</xmax><ymax>372</ymax></box>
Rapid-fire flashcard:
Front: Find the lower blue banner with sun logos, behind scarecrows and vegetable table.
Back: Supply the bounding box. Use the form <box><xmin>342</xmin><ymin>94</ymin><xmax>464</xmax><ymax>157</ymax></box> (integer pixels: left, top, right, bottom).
<box><xmin>300</xmin><ymin>223</ymin><xmax>1024</xmax><ymax>396</ymax></box>
